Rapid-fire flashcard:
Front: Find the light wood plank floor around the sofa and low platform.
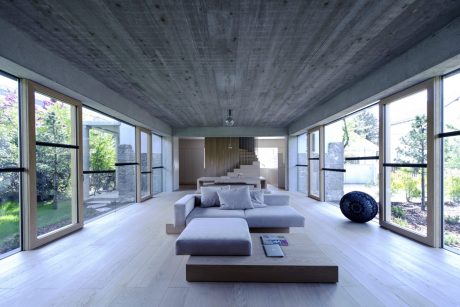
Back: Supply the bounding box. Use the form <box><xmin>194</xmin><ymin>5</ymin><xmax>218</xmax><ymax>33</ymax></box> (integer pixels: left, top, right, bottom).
<box><xmin>0</xmin><ymin>191</ymin><xmax>460</xmax><ymax>307</ymax></box>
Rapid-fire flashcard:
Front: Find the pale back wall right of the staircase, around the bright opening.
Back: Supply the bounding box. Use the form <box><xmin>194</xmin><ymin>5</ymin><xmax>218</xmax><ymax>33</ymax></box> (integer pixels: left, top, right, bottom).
<box><xmin>256</xmin><ymin>138</ymin><xmax>287</xmax><ymax>189</ymax></box>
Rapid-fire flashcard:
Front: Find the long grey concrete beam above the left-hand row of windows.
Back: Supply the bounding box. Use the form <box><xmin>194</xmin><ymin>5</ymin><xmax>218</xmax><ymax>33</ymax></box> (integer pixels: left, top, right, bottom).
<box><xmin>0</xmin><ymin>20</ymin><xmax>172</xmax><ymax>135</ymax></box>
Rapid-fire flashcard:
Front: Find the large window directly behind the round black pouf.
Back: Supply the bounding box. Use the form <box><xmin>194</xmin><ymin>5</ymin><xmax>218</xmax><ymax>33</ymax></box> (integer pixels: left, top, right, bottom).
<box><xmin>323</xmin><ymin>105</ymin><xmax>379</xmax><ymax>203</ymax></box>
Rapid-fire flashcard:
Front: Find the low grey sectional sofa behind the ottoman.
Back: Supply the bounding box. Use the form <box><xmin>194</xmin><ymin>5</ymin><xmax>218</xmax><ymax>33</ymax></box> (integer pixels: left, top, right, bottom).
<box><xmin>174</xmin><ymin>194</ymin><xmax>305</xmax><ymax>229</ymax></box>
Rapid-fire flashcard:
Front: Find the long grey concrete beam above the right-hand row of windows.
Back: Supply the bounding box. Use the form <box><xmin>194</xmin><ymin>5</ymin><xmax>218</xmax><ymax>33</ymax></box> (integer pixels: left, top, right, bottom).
<box><xmin>289</xmin><ymin>17</ymin><xmax>460</xmax><ymax>135</ymax></box>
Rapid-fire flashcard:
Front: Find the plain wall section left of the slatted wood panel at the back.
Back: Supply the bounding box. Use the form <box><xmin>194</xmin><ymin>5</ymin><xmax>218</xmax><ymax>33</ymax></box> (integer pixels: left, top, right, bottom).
<box><xmin>179</xmin><ymin>138</ymin><xmax>205</xmax><ymax>184</ymax></box>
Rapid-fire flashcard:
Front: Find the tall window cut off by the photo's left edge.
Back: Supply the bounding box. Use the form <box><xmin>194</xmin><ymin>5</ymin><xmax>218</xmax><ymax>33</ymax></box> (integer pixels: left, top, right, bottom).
<box><xmin>0</xmin><ymin>75</ymin><xmax>22</xmax><ymax>258</ymax></box>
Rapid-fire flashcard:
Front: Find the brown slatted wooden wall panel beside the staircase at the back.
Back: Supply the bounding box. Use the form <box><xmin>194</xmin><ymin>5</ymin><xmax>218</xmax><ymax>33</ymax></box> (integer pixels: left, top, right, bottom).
<box><xmin>204</xmin><ymin>138</ymin><xmax>239</xmax><ymax>176</ymax></box>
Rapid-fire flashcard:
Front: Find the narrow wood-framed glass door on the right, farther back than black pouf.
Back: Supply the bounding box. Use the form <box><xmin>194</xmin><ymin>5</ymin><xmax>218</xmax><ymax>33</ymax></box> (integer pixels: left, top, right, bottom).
<box><xmin>308</xmin><ymin>128</ymin><xmax>322</xmax><ymax>200</ymax></box>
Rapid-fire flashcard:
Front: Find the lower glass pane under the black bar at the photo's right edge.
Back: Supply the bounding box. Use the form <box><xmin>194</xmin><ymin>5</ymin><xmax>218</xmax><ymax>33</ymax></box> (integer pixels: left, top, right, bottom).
<box><xmin>443</xmin><ymin>136</ymin><xmax>460</xmax><ymax>252</ymax></box>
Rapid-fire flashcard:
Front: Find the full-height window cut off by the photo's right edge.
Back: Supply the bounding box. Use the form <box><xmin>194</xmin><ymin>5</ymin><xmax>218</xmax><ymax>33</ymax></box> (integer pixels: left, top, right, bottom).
<box><xmin>441</xmin><ymin>73</ymin><xmax>460</xmax><ymax>252</ymax></box>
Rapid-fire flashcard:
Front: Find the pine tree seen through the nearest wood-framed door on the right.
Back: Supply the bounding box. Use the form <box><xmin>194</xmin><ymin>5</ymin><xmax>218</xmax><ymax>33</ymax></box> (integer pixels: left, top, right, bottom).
<box><xmin>396</xmin><ymin>115</ymin><xmax>427</xmax><ymax>210</ymax></box>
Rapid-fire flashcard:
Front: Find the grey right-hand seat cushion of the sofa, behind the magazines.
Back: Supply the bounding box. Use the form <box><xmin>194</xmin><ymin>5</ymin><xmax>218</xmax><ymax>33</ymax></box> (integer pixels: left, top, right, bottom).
<box><xmin>244</xmin><ymin>206</ymin><xmax>305</xmax><ymax>228</ymax></box>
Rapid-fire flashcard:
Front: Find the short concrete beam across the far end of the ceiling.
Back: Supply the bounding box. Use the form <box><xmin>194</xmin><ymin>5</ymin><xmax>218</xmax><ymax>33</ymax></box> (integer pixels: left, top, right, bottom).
<box><xmin>173</xmin><ymin>127</ymin><xmax>287</xmax><ymax>137</ymax></box>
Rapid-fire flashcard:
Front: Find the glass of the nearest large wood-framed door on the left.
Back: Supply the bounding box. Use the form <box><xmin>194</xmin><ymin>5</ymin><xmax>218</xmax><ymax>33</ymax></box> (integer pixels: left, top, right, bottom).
<box><xmin>34</xmin><ymin>89</ymin><xmax>78</xmax><ymax>236</ymax></box>
